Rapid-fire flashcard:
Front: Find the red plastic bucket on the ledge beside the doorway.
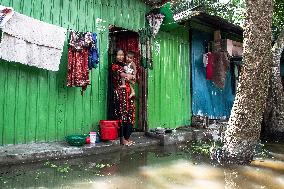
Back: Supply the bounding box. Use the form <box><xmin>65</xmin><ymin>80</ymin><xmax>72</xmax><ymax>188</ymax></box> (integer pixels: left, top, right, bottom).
<box><xmin>100</xmin><ymin>120</ymin><xmax>119</xmax><ymax>140</ymax></box>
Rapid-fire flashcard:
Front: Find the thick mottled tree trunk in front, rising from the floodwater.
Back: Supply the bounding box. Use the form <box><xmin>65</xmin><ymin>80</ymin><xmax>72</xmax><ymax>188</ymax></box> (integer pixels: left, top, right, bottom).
<box><xmin>218</xmin><ymin>0</ymin><xmax>273</xmax><ymax>163</ymax></box>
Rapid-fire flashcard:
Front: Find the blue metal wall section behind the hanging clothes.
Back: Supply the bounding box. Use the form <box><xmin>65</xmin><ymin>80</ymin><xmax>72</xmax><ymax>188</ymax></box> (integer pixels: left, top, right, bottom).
<box><xmin>191</xmin><ymin>29</ymin><xmax>234</xmax><ymax>119</ymax></box>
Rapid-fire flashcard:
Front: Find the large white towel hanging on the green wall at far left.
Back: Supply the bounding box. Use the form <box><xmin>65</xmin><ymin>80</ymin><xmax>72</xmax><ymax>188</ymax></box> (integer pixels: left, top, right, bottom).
<box><xmin>0</xmin><ymin>12</ymin><xmax>67</xmax><ymax>71</ymax></box>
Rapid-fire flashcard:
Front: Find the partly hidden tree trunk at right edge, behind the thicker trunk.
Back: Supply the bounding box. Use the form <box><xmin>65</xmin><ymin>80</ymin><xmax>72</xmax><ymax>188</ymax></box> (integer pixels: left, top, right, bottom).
<box><xmin>262</xmin><ymin>30</ymin><xmax>284</xmax><ymax>140</ymax></box>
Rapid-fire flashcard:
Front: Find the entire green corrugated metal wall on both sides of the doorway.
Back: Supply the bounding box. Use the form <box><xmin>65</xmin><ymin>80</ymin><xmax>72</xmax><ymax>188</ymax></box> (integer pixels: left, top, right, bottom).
<box><xmin>0</xmin><ymin>0</ymin><xmax>191</xmax><ymax>145</ymax></box>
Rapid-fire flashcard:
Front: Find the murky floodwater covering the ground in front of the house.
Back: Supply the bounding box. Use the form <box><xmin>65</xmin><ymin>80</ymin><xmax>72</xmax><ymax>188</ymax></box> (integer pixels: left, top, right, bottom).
<box><xmin>0</xmin><ymin>143</ymin><xmax>284</xmax><ymax>189</ymax></box>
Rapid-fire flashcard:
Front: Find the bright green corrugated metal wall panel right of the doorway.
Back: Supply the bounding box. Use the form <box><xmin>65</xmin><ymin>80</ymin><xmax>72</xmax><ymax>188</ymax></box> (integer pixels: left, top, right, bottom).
<box><xmin>148</xmin><ymin>30</ymin><xmax>191</xmax><ymax>128</ymax></box>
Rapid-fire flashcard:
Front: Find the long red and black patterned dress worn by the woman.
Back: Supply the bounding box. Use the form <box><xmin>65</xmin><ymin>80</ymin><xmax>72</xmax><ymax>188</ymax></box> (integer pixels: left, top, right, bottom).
<box><xmin>112</xmin><ymin>62</ymin><xmax>135</xmax><ymax>125</ymax></box>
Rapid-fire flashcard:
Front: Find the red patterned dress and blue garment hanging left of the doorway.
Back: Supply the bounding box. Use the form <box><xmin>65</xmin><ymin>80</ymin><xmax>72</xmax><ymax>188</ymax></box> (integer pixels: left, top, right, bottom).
<box><xmin>67</xmin><ymin>31</ymin><xmax>99</xmax><ymax>95</ymax></box>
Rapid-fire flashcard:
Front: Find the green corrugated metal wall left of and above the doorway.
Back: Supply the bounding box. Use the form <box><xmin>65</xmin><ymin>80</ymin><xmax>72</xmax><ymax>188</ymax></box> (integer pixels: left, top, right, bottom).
<box><xmin>0</xmin><ymin>0</ymin><xmax>147</xmax><ymax>145</ymax></box>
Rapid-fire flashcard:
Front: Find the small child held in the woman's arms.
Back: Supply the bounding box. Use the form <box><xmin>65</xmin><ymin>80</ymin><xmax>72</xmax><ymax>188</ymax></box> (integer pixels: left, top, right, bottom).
<box><xmin>121</xmin><ymin>51</ymin><xmax>137</xmax><ymax>98</ymax></box>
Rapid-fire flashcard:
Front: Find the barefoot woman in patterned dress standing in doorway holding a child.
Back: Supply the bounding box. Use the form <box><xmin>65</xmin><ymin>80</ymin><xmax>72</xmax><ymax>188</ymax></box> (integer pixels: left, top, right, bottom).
<box><xmin>111</xmin><ymin>50</ymin><xmax>136</xmax><ymax>146</ymax></box>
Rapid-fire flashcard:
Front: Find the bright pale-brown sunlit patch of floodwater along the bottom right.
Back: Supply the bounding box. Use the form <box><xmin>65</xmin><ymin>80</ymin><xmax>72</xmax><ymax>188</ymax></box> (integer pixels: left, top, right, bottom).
<box><xmin>80</xmin><ymin>161</ymin><xmax>284</xmax><ymax>189</ymax></box>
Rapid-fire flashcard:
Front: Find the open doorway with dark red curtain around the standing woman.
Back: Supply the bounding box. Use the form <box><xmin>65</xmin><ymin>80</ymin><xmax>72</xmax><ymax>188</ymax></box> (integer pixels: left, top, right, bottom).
<box><xmin>108</xmin><ymin>26</ymin><xmax>148</xmax><ymax>131</ymax></box>
